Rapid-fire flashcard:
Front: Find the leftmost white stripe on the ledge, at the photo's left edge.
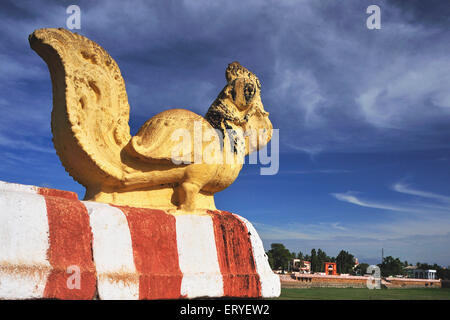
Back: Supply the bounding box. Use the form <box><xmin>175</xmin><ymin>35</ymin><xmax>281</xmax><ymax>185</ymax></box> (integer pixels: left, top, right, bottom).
<box><xmin>0</xmin><ymin>189</ymin><xmax>51</xmax><ymax>299</ymax></box>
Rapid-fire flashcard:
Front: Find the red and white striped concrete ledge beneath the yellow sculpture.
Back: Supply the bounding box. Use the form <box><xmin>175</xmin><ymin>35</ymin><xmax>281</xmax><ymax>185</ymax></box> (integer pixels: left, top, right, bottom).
<box><xmin>0</xmin><ymin>181</ymin><xmax>280</xmax><ymax>299</ymax></box>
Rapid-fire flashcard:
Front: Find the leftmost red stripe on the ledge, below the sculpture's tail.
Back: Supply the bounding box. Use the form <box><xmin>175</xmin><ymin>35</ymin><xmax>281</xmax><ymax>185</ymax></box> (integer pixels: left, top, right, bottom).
<box><xmin>38</xmin><ymin>189</ymin><xmax>97</xmax><ymax>300</ymax></box>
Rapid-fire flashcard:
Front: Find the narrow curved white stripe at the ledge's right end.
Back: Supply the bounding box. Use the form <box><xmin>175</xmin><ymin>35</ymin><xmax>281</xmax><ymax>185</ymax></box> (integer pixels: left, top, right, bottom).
<box><xmin>234</xmin><ymin>214</ymin><xmax>281</xmax><ymax>298</ymax></box>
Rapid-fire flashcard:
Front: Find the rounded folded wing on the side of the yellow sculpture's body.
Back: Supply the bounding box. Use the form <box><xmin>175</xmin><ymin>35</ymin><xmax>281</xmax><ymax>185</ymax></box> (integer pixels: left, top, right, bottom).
<box><xmin>126</xmin><ymin>109</ymin><xmax>221</xmax><ymax>164</ymax></box>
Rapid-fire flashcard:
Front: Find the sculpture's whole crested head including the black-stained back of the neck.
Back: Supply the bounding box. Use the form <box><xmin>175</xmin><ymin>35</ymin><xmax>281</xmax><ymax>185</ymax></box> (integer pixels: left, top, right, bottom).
<box><xmin>206</xmin><ymin>62</ymin><xmax>272</xmax><ymax>154</ymax></box>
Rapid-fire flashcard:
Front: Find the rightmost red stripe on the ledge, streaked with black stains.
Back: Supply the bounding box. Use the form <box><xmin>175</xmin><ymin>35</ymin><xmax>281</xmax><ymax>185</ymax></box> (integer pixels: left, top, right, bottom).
<box><xmin>209</xmin><ymin>211</ymin><xmax>261</xmax><ymax>297</ymax></box>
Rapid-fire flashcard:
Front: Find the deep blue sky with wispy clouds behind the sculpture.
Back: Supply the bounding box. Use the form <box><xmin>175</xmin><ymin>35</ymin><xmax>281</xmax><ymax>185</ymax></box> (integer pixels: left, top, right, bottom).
<box><xmin>0</xmin><ymin>0</ymin><xmax>450</xmax><ymax>265</ymax></box>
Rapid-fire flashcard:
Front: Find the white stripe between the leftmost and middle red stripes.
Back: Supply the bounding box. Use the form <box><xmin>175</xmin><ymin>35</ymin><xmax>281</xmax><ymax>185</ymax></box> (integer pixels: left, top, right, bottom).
<box><xmin>82</xmin><ymin>201</ymin><xmax>139</xmax><ymax>300</ymax></box>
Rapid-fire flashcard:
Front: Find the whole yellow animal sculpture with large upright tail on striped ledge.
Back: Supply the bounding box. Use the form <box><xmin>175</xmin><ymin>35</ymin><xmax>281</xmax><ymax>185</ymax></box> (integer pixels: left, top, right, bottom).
<box><xmin>29</xmin><ymin>29</ymin><xmax>272</xmax><ymax>212</ymax></box>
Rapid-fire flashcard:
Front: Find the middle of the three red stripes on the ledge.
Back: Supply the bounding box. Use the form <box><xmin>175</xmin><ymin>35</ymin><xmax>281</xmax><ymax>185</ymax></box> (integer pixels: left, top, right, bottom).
<box><xmin>118</xmin><ymin>206</ymin><xmax>183</xmax><ymax>299</ymax></box>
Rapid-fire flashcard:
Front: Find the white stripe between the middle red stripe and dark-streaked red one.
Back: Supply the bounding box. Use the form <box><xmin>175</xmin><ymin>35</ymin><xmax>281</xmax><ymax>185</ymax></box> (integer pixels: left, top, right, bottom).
<box><xmin>176</xmin><ymin>215</ymin><xmax>223</xmax><ymax>298</ymax></box>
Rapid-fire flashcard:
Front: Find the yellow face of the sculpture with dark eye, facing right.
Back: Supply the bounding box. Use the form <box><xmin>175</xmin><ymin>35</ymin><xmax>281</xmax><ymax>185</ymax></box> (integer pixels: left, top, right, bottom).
<box><xmin>224</xmin><ymin>62</ymin><xmax>272</xmax><ymax>153</ymax></box>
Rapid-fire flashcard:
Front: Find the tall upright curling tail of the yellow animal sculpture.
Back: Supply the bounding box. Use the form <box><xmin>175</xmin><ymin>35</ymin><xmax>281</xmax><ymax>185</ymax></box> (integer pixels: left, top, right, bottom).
<box><xmin>29</xmin><ymin>29</ymin><xmax>131</xmax><ymax>185</ymax></box>
